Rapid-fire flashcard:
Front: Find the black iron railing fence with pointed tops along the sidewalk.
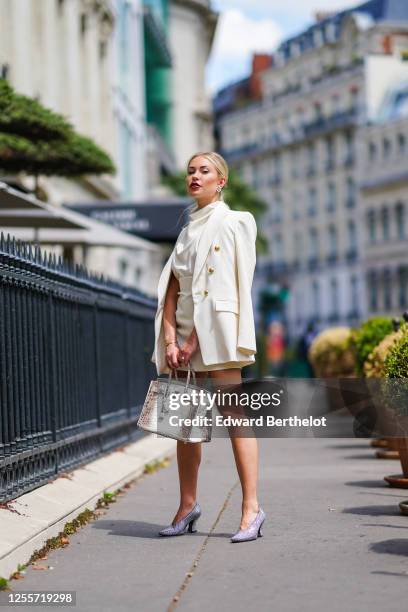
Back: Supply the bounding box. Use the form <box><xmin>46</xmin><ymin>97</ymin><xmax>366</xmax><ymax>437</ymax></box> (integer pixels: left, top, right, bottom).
<box><xmin>0</xmin><ymin>233</ymin><xmax>157</xmax><ymax>502</ymax></box>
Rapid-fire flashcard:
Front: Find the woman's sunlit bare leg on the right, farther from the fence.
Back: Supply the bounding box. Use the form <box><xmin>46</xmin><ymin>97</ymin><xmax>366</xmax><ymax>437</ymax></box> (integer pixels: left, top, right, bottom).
<box><xmin>210</xmin><ymin>368</ymin><xmax>259</xmax><ymax>529</ymax></box>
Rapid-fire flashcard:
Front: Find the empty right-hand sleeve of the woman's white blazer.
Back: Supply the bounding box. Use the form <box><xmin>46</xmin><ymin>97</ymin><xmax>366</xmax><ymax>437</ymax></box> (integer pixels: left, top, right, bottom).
<box><xmin>234</xmin><ymin>211</ymin><xmax>257</xmax><ymax>355</ymax></box>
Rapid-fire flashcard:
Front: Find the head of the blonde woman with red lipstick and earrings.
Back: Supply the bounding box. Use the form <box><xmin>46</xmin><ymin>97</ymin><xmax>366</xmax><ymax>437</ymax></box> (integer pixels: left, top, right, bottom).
<box><xmin>186</xmin><ymin>155</ymin><xmax>225</xmax><ymax>202</ymax></box>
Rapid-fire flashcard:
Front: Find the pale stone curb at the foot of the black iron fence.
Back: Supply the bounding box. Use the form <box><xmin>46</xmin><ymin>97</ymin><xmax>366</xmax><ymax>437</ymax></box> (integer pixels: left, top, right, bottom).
<box><xmin>0</xmin><ymin>434</ymin><xmax>177</xmax><ymax>579</ymax></box>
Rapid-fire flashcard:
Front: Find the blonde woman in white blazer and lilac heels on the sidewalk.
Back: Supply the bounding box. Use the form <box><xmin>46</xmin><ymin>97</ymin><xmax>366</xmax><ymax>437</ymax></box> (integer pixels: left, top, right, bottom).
<box><xmin>152</xmin><ymin>152</ymin><xmax>265</xmax><ymax>542</ymax></box>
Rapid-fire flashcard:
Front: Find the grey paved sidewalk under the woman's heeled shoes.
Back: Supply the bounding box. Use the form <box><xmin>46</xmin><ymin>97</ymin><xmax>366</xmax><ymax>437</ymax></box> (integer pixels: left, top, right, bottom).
<box><xmin>0</xmin><ymin>438</ymin><xmax>408</xmax><ymax>612</ymax></box>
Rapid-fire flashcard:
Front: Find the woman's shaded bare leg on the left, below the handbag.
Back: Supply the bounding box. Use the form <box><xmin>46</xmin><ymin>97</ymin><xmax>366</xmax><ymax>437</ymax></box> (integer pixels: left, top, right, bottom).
<box><xmin>173</xmin><ymin>370</ymin><xmax>207</xmax><ymax>525</ymax></box>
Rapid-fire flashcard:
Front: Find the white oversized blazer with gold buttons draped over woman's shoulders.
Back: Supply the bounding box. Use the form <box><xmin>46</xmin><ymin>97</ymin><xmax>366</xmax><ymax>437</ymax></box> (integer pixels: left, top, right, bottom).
<box><xmin>151</xmin><ymin>201</ymin><xmax>257</xmax><ymax>375</ymax></box>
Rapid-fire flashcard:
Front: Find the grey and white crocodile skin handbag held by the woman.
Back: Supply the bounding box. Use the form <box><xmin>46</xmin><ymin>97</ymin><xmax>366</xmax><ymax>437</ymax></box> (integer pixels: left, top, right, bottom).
<box><xmin>137</xmin><ymin>364</ymin><xmax>212</xmax><ymax>442</ymax></box>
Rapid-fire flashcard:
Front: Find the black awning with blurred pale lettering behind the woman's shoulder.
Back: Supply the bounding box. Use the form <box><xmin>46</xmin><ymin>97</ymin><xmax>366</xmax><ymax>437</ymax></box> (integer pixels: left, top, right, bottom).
<box><xmin>64</xmin><ymin>198</ymin><xmax>193</xmax><ymax>242</ymax></box>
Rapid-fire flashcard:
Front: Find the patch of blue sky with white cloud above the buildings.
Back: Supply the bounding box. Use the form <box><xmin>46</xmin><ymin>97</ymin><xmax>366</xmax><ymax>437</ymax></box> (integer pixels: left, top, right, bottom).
<box><xmin>206</xmin><ymin>0</ymin><xmax>363</xmax><ymax>96</ymax></box>
